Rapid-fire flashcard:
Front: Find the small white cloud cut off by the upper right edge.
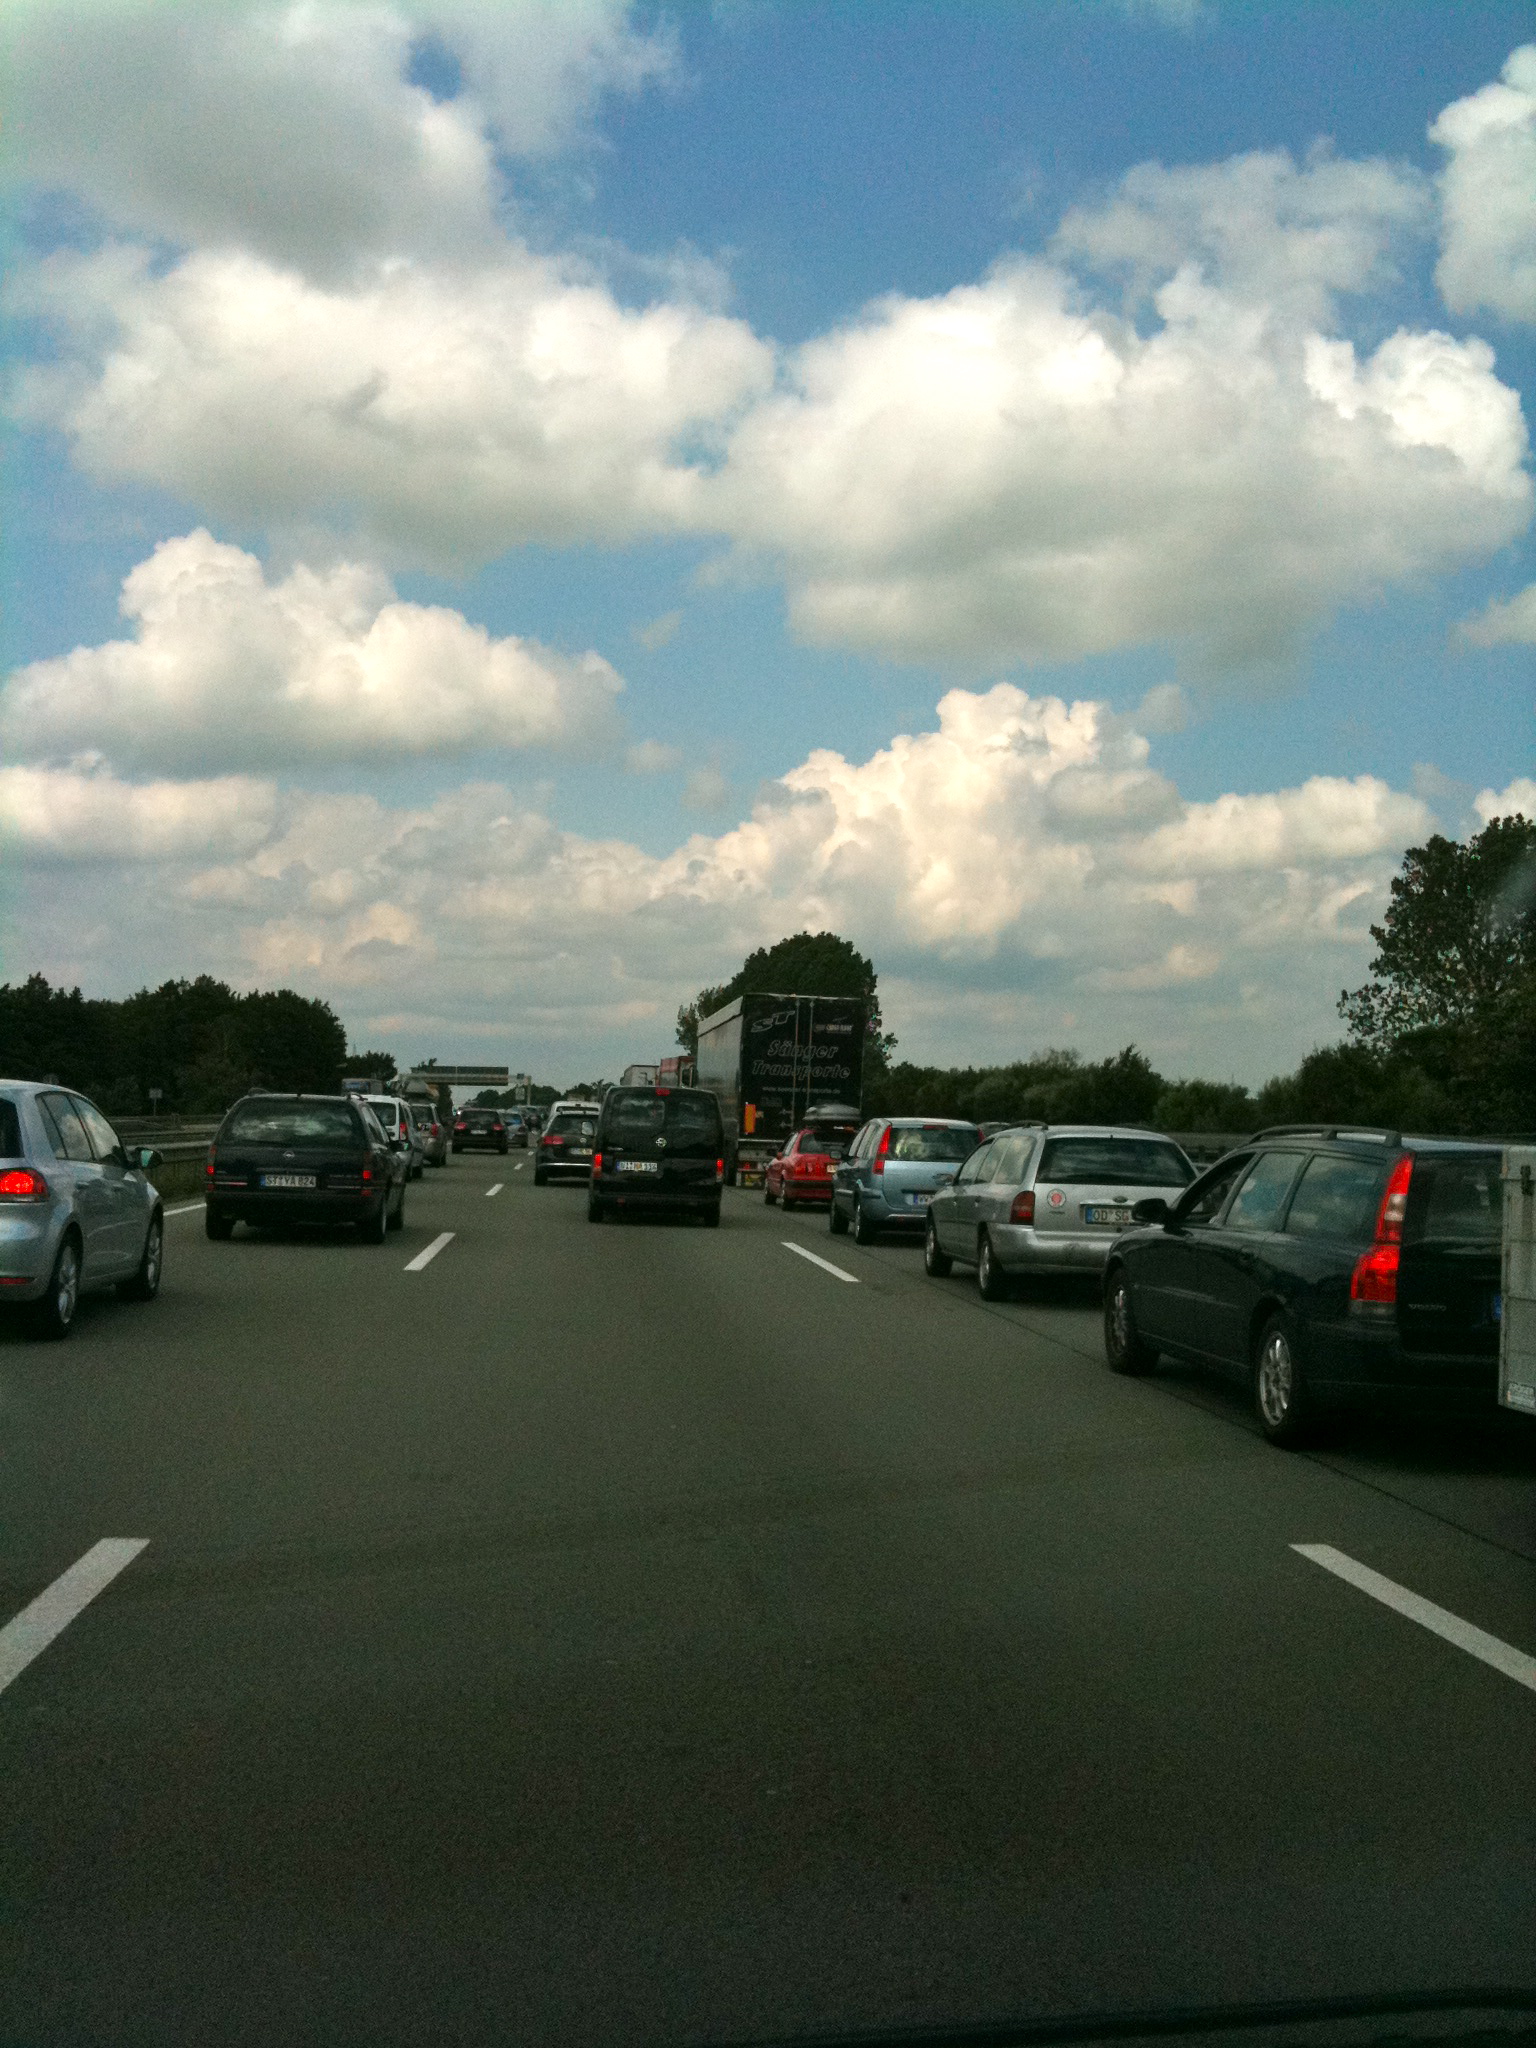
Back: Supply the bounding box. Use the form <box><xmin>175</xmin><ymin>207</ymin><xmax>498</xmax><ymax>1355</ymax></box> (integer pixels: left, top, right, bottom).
<box><xmin>1430</xmin><ymin>43</ymin><xmax>1536</xmax><ymax>319</ymax></box>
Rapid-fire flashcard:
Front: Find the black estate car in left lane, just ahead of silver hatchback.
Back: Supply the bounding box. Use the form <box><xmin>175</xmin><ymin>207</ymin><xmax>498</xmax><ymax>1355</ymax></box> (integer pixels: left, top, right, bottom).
<box><xmin>205</xmin><ymin>1096</ymin><xmax>410</xmax><ymax>1245</ymax></box>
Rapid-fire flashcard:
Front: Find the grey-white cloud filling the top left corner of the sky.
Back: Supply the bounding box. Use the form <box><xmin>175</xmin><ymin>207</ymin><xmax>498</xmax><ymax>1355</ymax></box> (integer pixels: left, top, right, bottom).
<box><xmin>0</xmin><ymin>0</ymin><xmax>672</xmax><ymax>272</ymax></box>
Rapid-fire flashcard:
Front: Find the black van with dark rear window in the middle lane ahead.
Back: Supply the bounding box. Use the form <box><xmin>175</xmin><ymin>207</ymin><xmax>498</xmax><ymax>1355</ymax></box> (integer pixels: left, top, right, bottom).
<box><xmin>586</xmin><ymin>1087</ymin><xmax>725</xmax><ymax>1227</ymax></box>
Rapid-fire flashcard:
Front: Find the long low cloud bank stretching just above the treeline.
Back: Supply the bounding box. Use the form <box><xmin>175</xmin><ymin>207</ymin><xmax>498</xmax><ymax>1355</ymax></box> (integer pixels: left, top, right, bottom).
<box><xmin>6</xmin><ymin>684</ymin><xmax>1434</xmax><ymax>1077</ymax></box>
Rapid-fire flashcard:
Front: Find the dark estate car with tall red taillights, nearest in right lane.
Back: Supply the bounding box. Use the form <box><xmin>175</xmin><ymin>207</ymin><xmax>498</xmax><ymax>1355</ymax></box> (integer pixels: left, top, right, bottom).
<box><xmin>1104</xmin><ymin>1124</ymin><xmax>1503</xmax><ymax>1446</ymax></box>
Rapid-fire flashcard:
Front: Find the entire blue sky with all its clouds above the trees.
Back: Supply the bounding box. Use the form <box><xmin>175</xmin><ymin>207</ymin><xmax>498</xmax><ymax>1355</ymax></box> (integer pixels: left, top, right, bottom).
<box><xmin>0</xmin><ymin>0</ymin><xmax>1536</xmax><ymax>1079</ymax></box>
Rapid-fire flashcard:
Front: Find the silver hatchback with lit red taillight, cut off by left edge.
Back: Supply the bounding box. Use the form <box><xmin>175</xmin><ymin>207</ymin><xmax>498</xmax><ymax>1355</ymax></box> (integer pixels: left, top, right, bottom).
<box><xmin>0</xmin><ymin>1081</ymin><xmax>166</xmax><ymax>1337</ymax></box>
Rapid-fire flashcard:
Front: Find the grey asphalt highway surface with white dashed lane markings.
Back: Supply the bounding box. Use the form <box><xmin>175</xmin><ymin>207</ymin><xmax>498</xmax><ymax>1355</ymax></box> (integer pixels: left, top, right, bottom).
<box><xmin>0</xmin><ymin>1153</ymin><xmax>1536</xmax><ymax>2048</ymax></box>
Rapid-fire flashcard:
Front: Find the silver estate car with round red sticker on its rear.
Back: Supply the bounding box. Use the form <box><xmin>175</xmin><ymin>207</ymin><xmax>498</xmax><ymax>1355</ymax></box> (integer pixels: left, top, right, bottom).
<box><xmin>924</xmin><ymin>1124</ymin><xmax>1194</xmax><ymax>1300</ymax></box>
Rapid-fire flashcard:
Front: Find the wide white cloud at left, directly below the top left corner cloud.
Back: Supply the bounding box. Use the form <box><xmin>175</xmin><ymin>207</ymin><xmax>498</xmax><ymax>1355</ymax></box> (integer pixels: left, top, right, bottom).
<box><xmin>14</xmin><ymin>244</ymin><xmax>772</xmax><ymax>567</ymax></box>
